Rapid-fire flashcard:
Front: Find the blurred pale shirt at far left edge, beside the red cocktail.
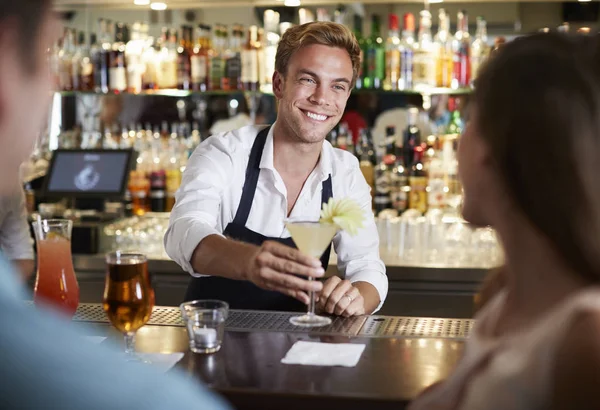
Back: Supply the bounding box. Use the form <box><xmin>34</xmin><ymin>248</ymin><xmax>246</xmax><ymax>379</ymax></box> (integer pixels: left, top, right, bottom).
<box><xmin>0</xmin><ymin>187</ymin><xmax>33</xmax><ymax>260</ymax></box>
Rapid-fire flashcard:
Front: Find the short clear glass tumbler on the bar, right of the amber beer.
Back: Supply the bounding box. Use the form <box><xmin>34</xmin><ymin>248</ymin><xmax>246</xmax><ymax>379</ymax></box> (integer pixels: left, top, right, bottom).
<box><xmin>179</xmin><ymin>300</ymin><xmax>229</xmax><ymax>354</ymax></box>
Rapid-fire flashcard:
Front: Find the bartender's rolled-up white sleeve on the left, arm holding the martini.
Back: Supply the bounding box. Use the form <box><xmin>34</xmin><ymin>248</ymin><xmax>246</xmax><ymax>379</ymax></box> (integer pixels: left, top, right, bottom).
<box><xmin>164</xmin><ymin>137</ymin><xmax>233</xmax><ymax>276</ymax></box>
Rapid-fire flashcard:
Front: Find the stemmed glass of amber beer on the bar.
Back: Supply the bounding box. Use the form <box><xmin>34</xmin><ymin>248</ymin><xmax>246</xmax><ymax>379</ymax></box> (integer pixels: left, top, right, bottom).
<box><xmin>103</xmin><ymin>251</ymin><xmax>154</xmax><ymax>360</ymax></box>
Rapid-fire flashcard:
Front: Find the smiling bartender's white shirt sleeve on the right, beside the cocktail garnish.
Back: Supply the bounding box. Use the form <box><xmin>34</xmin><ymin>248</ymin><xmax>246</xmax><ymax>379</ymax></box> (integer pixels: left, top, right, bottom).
<box><xmin>334</xmin><ymin>159</ymin><xmax>388</xmax><ymax>311</ymax></box>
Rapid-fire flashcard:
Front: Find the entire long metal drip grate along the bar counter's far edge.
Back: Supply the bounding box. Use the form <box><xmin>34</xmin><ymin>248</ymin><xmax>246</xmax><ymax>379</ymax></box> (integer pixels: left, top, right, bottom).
<box><xmin>73</xmin><ymin>303</ymin><xmax>473</xmax><ymax>340</ymax></box>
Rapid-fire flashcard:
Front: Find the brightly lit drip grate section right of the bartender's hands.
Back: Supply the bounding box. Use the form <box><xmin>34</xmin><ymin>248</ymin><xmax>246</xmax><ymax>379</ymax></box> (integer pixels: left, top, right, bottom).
<box><xmin>359</xmin><ymin>316</ymin><xmax>473</xmax><ymax>339</ymax></box>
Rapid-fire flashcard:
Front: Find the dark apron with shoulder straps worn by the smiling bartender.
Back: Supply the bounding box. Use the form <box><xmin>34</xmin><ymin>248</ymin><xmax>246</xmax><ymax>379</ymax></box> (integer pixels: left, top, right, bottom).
<box><xmin>185</xmin><ymin>127</ymin><xmax>333</xmax><ymax>312</ymax></box>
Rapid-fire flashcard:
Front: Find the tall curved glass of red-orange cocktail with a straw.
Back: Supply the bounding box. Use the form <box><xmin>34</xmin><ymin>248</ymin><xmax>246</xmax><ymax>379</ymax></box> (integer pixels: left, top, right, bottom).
<box><xmin>33</xmin><ymin>219</ymin><xmax>79</xmax><ymax>317</ymax></box>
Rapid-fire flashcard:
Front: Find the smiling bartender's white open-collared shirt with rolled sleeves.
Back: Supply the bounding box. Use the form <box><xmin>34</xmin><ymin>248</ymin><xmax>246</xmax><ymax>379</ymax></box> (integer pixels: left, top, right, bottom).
<box><xmin>165</xmin><ymin>126</ymin><xmax>388</xmax><ymax>309</ymax></box>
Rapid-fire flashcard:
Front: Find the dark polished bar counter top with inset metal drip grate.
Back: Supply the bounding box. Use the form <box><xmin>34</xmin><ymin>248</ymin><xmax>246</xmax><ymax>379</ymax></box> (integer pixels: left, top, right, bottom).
<box><xmin>74</xmin><ymin>304</ymin><xmax>472</xmax><ymax>410</ymax></box>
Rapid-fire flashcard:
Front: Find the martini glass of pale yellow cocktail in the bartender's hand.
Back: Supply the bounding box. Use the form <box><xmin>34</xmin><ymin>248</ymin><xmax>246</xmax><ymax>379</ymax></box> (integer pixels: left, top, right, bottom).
<box><xmin>285</xmin><ymin>219</ymin><xmax>338</xmax><ymax>327</ymax></box>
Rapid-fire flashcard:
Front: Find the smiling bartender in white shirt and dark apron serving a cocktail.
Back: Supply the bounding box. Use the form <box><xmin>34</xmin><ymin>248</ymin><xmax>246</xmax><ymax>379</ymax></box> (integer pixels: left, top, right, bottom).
<box><xmin>165</xmin><ymin>22</ymin><xmax>388</xmax><ymax>316</ymax></box>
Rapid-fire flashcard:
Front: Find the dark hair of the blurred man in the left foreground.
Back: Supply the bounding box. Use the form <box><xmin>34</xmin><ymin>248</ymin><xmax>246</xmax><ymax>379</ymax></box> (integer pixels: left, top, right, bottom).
<box><xmin>0</xmin><ymin>0</ymin><xmax>52</xmax><ymax>71</ymax></box>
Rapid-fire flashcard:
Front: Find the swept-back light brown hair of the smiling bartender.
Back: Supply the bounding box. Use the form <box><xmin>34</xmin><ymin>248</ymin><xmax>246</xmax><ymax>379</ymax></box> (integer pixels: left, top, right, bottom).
<box><xmin>275</xmin><ymin>21</ymin><xmax>361</xmax><ymax>87</ymax></box>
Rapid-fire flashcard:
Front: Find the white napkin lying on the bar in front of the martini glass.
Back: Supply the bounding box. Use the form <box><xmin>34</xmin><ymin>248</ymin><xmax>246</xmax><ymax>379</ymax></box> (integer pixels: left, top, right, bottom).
<box><xmin>281</xmin><ymin>340</ymin><xmax>365</xmax><ymax>367</ymax></box>
